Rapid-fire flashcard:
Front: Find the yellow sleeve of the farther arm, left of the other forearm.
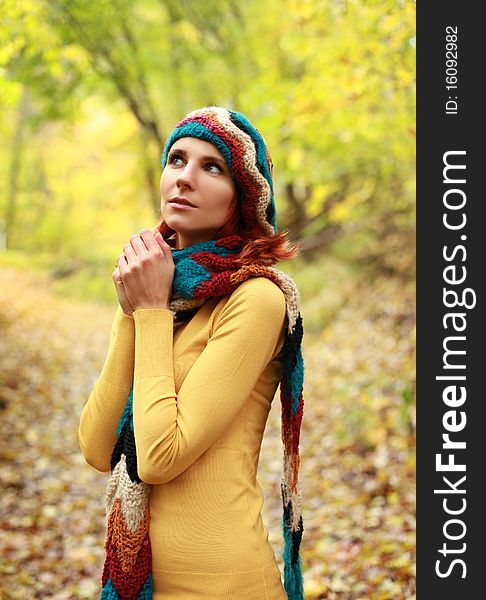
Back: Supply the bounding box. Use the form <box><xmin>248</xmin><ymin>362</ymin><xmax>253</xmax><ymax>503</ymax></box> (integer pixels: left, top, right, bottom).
<box><xmin>78</xmin><ymin>306</ymin><xmax>135</xmax><ymax>472</ymax></box>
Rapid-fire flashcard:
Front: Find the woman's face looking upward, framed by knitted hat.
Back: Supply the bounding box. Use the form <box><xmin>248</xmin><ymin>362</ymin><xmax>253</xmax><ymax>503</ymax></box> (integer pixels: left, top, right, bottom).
<box><xmin>160</xmin><ymin>137</ymin><xmax>237</xmax><ymax>248</ymax></box>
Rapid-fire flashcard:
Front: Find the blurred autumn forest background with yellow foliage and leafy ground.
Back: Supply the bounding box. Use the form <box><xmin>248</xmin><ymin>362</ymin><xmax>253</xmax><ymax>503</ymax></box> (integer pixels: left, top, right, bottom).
<box><xmin>0</xmin><ymin>0</ymin><xmax>416</xmax><ymax>600</ymax></box>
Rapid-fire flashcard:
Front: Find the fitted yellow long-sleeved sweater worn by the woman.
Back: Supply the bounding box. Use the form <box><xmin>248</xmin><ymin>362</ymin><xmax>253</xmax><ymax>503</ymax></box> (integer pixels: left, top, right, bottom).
<box><xmin>79</xmin><ymin>277</ymin><xmax>287</xmax><ymax>600</ymax></box>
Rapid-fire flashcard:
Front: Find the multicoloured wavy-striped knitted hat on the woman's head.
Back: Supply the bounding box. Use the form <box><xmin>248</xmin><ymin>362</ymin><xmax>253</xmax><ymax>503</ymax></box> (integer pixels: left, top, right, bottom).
<box><xmin>161</xmin><ymin>106</ymin><xmax>277</xmax><ymax>236</ymax></box>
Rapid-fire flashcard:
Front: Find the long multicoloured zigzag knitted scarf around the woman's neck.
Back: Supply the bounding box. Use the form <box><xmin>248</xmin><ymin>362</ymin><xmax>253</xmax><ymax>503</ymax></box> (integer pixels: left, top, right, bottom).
<box><xmin>101</xmin><ymin>236</ymin><xmax>304</xmax><ymax>600</ymax></box>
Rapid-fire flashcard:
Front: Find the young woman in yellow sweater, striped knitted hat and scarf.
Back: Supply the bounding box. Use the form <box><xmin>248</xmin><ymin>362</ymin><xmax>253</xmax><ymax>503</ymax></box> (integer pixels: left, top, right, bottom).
<box><xmin>79</xmin><ymin>107</ymin><xmax>303</xmax><ymax>600</ymax></box>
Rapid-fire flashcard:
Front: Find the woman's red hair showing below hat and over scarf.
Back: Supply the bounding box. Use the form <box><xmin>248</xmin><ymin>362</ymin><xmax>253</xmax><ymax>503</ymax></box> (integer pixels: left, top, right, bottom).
<box><xmin>153</xmin><ymin>199</ymin><xmax>300</xmax><ymax>266</ymax></box>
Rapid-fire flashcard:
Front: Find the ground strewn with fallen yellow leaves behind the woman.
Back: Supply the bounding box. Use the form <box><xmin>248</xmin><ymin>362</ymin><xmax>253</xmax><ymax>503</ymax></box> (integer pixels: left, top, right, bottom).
<box><xmin>0</xmin><ymin>268</ymin><xmax>415</xmax><ymax>600</ymax></box>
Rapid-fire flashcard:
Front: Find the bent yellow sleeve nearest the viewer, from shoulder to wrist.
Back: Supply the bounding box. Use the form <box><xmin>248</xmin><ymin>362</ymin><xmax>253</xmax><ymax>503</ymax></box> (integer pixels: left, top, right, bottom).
<box><xmin>133</xmin><ymin>278</ymin><xmax>286</xmax><ymax>484</ymax></box>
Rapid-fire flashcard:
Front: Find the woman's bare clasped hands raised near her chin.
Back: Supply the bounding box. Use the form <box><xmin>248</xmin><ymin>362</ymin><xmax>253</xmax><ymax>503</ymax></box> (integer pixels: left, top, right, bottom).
<box><xmin>113</xmin><ymin>229</ymin><xmax>175</xmax><ymax>315</ymax></box>
